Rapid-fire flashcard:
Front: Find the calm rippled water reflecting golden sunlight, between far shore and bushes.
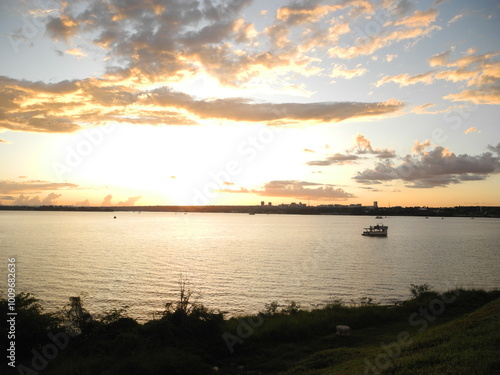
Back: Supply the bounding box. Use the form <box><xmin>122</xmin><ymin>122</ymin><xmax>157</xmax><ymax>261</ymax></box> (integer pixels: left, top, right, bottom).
<box><xmin>0</xmin><ymin>211</ymin><xmax>500</xmax><ymax>319</ymax></box>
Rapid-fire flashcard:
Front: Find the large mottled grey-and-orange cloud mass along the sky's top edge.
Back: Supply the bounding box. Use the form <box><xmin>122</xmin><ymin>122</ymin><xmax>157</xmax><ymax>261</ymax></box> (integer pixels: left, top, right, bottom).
<box><xmin>33</xmin><ymin>0</ymin><xmax>438</xmax><ymax>86</ymax></box>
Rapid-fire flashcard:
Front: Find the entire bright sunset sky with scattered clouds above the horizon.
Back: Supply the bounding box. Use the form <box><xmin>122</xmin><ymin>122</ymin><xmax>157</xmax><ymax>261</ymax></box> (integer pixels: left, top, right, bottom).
<box><xmin>0</xmin><ymin>0</ymin><xmax>500</xmax><ymax>207</ymax></box>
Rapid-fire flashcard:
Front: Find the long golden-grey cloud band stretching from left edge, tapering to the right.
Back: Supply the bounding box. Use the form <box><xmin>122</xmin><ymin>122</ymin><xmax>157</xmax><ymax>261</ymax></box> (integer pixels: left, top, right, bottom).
<box><xmin>0</xmin><ymin>76</ymin><xmax>403</xmax><ymax>133</ymax></box>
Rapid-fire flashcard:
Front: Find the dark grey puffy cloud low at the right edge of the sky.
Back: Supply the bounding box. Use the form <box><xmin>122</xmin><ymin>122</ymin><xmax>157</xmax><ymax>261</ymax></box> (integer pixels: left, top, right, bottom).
<box><xmin>353</xmin><ymin>141</ymin><xmax>500</xmax><ymax>188</ymax></box>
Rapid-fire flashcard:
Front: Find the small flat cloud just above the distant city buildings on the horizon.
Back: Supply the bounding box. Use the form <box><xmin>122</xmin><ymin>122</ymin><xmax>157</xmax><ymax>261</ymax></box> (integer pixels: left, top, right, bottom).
<box><xmin>220</xmin><ymin>180</ymin><xmax>355</xmax><ymax>200</ymax></box>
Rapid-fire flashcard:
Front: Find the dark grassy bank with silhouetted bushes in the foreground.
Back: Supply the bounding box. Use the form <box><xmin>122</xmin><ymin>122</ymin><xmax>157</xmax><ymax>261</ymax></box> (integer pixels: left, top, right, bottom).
<box><xmin>0</xmin><ymin>282</ymin><xmax>500</xmax><ymax>375</ymax></box>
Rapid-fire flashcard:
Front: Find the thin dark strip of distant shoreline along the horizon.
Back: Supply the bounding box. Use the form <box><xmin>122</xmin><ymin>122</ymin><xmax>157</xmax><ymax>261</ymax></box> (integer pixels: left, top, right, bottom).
<box><xmin>0</xmin><ymin>204</ymin><xmax>500</xmax><ymax>218</ymax></box>
